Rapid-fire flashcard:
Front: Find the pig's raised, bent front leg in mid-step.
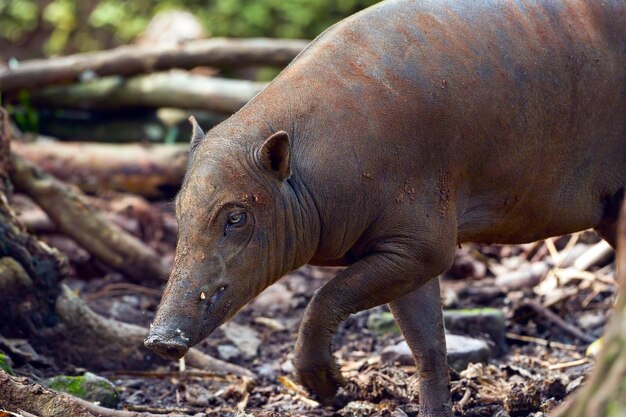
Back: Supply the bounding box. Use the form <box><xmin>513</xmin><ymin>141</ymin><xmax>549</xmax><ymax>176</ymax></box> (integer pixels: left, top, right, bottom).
<box><xmin>295</xmin><ymin>239</ymin><xmax>455</xmax><ymax>410</ymax></box>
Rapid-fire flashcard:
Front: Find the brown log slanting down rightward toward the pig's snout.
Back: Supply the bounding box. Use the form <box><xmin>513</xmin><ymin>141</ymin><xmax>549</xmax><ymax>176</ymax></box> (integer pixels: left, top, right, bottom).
<box><xmin>11</xmin><ymin>154</ymin><xmax>169</xmax><ymax>282</ymax></box>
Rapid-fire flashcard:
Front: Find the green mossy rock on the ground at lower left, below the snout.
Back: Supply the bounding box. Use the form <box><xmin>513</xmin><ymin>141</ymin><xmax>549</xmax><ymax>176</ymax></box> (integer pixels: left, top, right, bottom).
<box><xmin>48</xmin><ymin>372</ymin><xmax>120</xmax><ymax>408</ymax></box>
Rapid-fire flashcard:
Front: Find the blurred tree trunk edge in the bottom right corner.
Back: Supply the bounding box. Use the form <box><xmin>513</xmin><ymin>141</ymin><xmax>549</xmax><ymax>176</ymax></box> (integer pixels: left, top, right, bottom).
<box><xmin>554</xmin><ymin>200</ymin><xmax>626</xmax><ymax>417</ymax></box>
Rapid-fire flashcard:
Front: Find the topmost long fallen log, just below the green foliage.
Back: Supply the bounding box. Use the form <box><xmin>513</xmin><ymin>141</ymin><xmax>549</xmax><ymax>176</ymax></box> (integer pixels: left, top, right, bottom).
<box><xmin>0</xmin><ymin>38</ymin><xmax>308</xmax><ymax>94</ymax></box>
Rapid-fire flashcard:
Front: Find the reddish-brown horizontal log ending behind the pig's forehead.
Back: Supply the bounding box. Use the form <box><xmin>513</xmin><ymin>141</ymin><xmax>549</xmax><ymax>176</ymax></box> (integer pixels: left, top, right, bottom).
<box><xmin>13</xmin><ymin>141</ymin><xmax>189</xmax><ymax>198</ymax></box>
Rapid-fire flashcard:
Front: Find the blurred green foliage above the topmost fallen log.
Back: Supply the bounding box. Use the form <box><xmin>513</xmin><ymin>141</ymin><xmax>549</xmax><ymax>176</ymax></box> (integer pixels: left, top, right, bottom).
<box><xmin>0</xmin><ymin>0</ymin><xmax>378</xmax><ymax>60</ymax></box>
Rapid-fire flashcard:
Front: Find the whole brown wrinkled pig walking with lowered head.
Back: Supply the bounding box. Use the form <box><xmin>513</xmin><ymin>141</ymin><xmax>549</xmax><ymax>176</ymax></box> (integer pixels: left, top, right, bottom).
<box><xmin>146</xmin><ymin>0</ymin><xmax>626</xmax><ymax>417</ymax></box>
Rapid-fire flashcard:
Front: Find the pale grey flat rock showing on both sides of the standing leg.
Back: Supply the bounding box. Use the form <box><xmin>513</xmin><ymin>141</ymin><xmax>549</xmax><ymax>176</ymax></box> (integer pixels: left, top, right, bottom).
<box><xmin>380</xmin><ymin>334</ymin><xmax>490</xmax><ymax>372</ymax></box>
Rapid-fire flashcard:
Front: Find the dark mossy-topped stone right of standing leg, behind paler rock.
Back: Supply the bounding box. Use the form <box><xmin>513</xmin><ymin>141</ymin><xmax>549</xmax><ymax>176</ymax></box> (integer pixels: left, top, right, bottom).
<box><xmin>443</xmin><ymin>308</ymin><xmax>507</xmax><ymax>355</ymax></box>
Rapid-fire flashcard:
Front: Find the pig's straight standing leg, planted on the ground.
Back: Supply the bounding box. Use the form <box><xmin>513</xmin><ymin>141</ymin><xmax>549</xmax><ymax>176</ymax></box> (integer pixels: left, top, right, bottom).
<box><xmin>389</xmin><ymin>278</ymin><xmax>452</xmax><ymax>417</ymax></box>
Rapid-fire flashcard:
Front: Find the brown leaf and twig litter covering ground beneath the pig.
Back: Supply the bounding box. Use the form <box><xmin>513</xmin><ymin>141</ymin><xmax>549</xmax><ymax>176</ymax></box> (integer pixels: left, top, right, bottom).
<box><xmin>2</xmin><ymin>195</ymin><xmax>615</xmax><ymax>417</ymax></box>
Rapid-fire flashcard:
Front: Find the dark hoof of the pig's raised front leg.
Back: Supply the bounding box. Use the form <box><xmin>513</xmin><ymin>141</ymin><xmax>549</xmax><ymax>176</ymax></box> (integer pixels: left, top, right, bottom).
<box><xmin>296</xmin><ymin>361</ymin><xmax>346</xmax><ymax>408</ymax></box>
